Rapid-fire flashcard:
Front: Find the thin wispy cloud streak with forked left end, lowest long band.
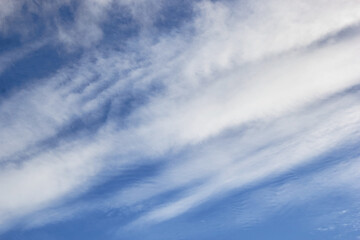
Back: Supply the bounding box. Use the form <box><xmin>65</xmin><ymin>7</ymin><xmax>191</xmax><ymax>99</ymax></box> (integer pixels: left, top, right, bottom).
<box><xmin>131</xmin><ymin>92</ymin><xmax>360</xmax><ymax>223</ymax></box>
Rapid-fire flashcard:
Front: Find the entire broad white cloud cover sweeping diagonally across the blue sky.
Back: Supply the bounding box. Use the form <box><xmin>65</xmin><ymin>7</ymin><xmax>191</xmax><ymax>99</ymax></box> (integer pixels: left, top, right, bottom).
<box><xmin>0</xmin><ymin>0</ymin><xmax>360</xmax><ymax>234</ymax></box>
